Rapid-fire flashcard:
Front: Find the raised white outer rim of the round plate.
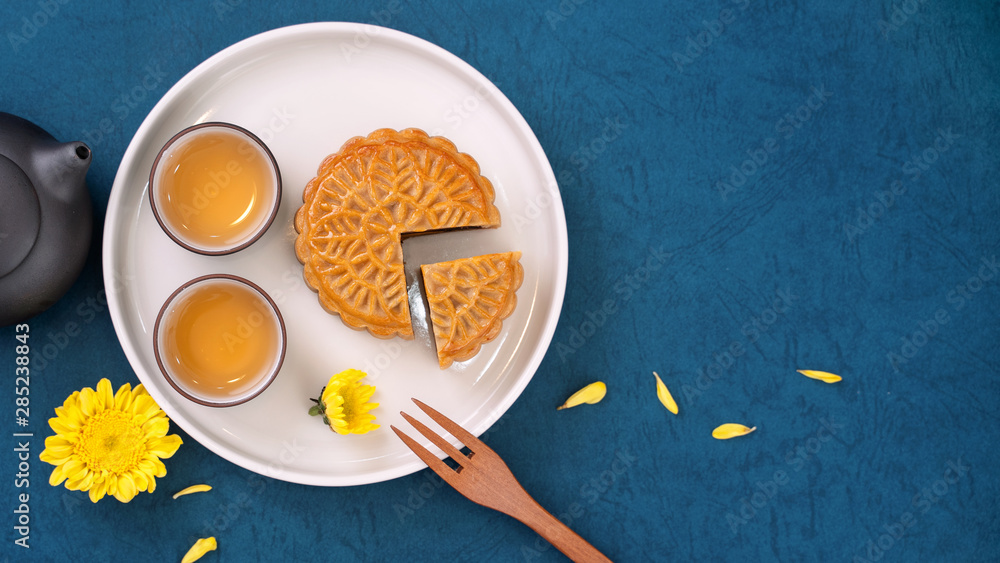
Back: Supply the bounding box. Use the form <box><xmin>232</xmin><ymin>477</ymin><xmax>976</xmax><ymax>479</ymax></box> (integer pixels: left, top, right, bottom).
<box><xmin>101</xmin><ymin>22</ymin><xmax>569</xmax><ymax>486</ymax></box>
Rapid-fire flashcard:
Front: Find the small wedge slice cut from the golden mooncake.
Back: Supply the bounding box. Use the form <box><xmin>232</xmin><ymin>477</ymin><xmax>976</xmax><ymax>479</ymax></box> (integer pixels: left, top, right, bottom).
<box><xmin>420</xmin><ymin>252</ymin><xmax>524</xmax><ymax>369</ymax></box>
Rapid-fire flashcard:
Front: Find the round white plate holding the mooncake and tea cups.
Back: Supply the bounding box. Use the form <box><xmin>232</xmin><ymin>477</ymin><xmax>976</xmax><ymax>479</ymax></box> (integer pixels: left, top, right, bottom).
<box><xmin>104</xmin><ymin>23</ymin><xmax>568</xmax><ymax>486</ymax></box>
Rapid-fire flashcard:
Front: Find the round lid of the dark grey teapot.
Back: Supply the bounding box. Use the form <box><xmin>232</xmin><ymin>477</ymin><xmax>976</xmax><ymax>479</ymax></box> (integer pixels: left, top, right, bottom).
<box><xmin>0</xmin><ymin>154</ymin><xmax>41</xmax><ymax>278</ymax></box>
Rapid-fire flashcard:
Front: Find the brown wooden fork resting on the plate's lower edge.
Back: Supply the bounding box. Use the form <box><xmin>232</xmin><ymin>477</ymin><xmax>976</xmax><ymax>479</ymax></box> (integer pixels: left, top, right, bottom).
<box><xmin>390</xmin><ymin>399</ymin><xmax>611</xmax><ymax>562</ymax></box>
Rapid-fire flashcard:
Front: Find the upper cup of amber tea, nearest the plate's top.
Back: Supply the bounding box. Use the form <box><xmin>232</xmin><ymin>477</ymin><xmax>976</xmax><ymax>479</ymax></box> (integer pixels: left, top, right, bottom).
<box><xmin>149</xmin><ymin>122</ymin><xmax>281</xmax><ymax>256</ymax></box>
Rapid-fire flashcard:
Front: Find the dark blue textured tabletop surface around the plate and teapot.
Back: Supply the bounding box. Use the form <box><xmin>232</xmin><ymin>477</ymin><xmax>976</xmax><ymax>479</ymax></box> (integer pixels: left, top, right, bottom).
<box><xmin>0</xmin><ymin>0</ymin><xmax>1000</xmax><ymax>561</ymax></box>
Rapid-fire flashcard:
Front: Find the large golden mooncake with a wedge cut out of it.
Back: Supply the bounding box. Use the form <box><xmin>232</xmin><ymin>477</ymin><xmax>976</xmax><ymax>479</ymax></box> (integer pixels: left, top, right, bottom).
<box><xmin>295</xmin><ymin>129</ymin><xmax>500</xmax><ymax>339</ymax></box>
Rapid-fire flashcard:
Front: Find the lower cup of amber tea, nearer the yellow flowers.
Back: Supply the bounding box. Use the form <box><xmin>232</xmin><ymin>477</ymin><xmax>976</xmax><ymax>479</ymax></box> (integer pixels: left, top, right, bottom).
<box><xmin>153</xmin><ymin>274</ymin><xmax>287</xmax><ymax>407</ymax></box>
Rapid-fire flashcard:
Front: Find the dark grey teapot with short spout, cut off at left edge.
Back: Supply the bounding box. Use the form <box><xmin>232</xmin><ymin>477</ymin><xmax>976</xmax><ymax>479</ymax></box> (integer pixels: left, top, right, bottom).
<box><xmin>0</xmin><ymin>112</ymin><xmax>93</xmax><ymax>326</ymax></box>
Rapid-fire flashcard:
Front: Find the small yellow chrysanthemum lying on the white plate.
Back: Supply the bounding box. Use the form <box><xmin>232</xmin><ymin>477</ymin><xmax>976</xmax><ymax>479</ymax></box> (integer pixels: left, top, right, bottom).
<box><xmin>310</xmin><ymin>369</ymin><xmax>379</xmax><ymax>434</ymax></box>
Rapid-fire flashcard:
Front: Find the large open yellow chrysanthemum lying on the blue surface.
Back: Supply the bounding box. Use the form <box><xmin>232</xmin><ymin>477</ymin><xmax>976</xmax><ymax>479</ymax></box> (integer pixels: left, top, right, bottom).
<box><xmin>39</xmin><ymin>379</ymin><xmax>181</xmax><ymax>502</ymax></box>
